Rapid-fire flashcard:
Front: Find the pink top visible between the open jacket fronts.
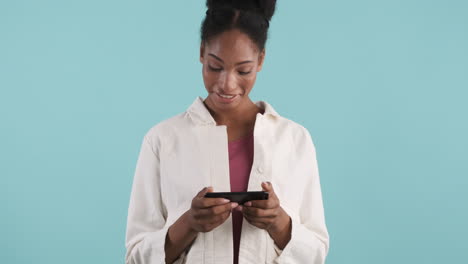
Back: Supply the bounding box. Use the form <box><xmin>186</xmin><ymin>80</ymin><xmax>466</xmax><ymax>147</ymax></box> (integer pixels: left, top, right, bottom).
<box><xmin>228</xmin><ymin>131</ymin><xmax>253</xmax><ymax>264</ymax></box>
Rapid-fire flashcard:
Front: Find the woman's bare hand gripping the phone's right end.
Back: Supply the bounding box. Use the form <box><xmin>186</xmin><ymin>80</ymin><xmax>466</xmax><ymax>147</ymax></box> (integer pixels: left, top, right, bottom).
<box><xmin>236</xmin><ymin>182</ymin><xmax>291</xmax><ymax>249</ymax></box>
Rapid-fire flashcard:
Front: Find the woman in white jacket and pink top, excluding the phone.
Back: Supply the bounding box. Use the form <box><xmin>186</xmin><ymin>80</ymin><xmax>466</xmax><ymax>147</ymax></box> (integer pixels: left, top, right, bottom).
<box><xmin>126</xmin><ymin>0</ymin><xmax>329</xmax><ymax>264</ymax></box>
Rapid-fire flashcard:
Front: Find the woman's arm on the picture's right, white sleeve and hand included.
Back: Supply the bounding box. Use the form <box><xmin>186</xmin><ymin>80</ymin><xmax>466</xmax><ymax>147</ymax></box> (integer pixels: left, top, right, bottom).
<box><xmin>239</xmin><ymin>129</ymin><xmax>329</xmax><ymax>264</ymax></box>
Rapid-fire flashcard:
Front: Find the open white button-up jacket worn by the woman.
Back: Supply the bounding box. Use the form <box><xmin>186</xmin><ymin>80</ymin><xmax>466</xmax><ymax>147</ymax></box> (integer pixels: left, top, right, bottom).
<box><xmin>125</xmin><ymin>97</ymin><xmax>329</xmax><ymax>264</ymax></box>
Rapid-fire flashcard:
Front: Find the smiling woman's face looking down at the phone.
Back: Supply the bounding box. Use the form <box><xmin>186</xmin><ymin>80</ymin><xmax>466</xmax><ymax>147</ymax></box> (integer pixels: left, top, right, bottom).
<box><xmin>200</xmin><ymin>30</ymin><xmax>265</xmax><ymax>111</ymax></box>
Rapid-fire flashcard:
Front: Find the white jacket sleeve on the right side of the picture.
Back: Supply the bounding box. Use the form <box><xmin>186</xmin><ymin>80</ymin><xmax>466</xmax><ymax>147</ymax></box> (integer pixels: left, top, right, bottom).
<box><xmin>275</xmin><ymin>127</ymin><xmax>329</xmax><ymax>264</ymax></box>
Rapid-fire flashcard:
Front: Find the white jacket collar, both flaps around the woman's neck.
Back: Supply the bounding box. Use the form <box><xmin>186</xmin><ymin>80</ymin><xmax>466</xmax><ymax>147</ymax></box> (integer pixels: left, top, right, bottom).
<box><xmin>186</xmin><ymin>96</ymin><xmax>280</xmax><ymax>125</ymax></box>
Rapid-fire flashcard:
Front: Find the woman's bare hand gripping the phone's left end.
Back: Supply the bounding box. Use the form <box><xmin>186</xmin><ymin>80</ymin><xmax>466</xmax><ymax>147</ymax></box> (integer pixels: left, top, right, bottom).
<box><xmin>187</xmin><ymin>187</ymin><xmax>238</xmax><ymax>232</ymax></box>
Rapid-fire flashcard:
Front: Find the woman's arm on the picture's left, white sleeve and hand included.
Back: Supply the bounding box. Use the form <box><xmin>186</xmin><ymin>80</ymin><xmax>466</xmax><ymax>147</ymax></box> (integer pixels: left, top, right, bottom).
<box><xmin>125</xmin><ymin>136</ymin><xmax>237</xmax><ymax>264</ymax></box>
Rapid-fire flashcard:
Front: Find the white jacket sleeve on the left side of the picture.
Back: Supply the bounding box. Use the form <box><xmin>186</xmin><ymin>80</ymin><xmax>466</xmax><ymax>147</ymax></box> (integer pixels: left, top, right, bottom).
<box><xmin>125</xmin><ymin>135</ymin><xmax>185</xmax><ymax>264</ymax></box>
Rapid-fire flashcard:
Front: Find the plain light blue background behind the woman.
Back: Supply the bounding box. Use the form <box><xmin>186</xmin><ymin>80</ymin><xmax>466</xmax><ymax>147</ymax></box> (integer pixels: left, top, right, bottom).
<box><xmin>0</xmin><ymin>0</ymin><xmax>468</xmax><ymax>264</ymax></box>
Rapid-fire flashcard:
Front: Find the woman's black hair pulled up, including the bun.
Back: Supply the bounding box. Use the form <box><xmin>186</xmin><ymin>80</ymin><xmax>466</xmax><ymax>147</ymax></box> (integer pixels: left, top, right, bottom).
<box><xmin>201</xmin><ymin>0</ymin><xmax>276</xmax><ymax>51</ymax></box>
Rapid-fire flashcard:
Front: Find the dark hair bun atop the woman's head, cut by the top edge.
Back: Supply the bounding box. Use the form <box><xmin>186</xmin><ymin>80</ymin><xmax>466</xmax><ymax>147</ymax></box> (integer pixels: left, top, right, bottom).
<box><xmin>206</xmin><ymin>0</ymin><xmax>276</xmax><ymax>21</ymax></box>
